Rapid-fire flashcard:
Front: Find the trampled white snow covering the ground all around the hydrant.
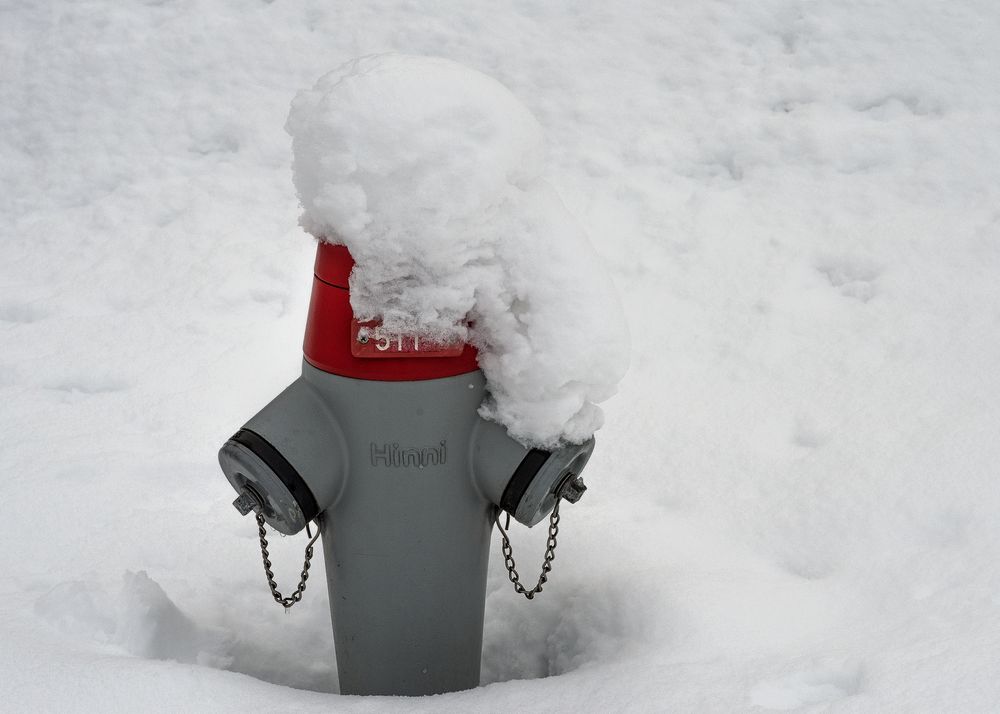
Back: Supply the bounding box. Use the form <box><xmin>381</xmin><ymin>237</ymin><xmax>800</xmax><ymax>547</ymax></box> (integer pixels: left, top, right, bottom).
<box><xmin>0</xmin><ymin>0</ymin><xmax>1000</xmax><ymax>712</ymax></box>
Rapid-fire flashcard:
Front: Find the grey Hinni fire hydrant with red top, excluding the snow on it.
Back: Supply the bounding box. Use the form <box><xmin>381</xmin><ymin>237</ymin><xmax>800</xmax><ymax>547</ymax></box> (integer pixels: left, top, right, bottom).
<box><xmin>219</xmin><ymin>242</ymin><xmax>594</xmax><ymax>695</ymax></box>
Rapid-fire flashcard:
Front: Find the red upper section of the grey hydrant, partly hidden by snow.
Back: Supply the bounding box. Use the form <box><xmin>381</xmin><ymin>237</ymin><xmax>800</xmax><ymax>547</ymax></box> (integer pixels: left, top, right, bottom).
<box><xmin>303</xmin><ymin>241</ymin><xmax>479</xmax><ymax>382</ymax></box>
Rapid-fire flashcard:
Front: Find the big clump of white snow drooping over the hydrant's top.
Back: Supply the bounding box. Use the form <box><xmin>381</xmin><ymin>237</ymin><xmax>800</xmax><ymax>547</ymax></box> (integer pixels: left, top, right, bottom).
<box><xmin>286</xmin><ymin>54</ymin><xmax>628</xmax><ymax>447</ymax></box>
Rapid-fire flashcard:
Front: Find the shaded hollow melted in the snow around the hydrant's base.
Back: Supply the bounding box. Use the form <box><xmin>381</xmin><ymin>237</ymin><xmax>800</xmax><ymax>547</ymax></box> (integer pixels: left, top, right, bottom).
<box><xmin>35</xmin><ymin>560</ymin><xmax>638</xmax><ymax>693</ymax></box>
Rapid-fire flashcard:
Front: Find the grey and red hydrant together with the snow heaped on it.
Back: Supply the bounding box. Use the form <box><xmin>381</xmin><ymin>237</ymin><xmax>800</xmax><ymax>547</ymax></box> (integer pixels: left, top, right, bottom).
<box><xmin>219</xmin><ymin>56</ymin><xmax>624</xmax><ymax>694</ymax></box>
